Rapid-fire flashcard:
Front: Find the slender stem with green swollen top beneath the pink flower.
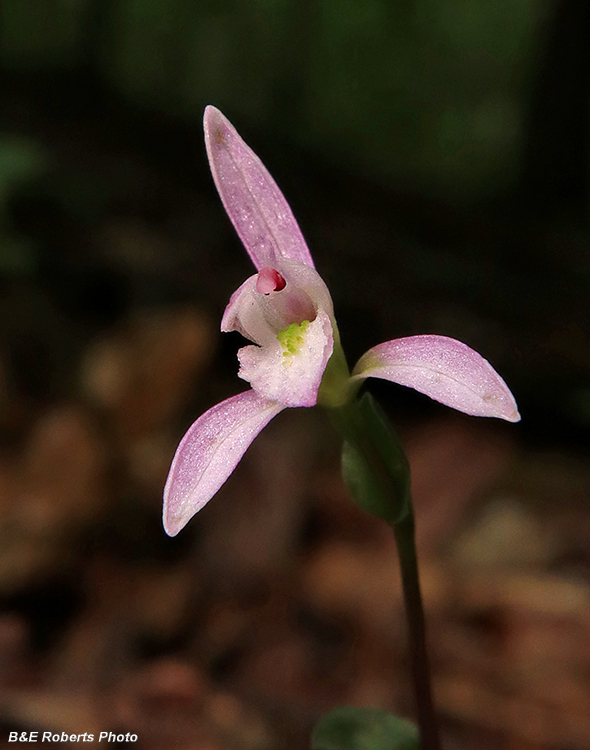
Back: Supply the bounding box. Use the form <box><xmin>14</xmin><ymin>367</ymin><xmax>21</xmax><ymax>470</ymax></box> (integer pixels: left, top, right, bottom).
<box><xmin>331</xmin><ymin>394</ymin><xmax>440</xmax><ymax>750</ymax></box>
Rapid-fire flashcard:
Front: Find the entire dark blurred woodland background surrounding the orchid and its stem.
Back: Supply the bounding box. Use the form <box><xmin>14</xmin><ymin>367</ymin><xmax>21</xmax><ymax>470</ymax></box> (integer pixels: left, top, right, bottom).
<box><xmin>0</xmin><ymin>0</ymin><xmax>590</xmax><ymax>750</ymax></box>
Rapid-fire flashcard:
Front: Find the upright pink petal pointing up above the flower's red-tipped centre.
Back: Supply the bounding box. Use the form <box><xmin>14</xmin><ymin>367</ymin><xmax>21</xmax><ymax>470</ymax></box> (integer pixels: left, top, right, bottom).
<box><xmin>204</xmin><ymin>105</ymin><xmax>314</xmax><ymax>269</ymax></box>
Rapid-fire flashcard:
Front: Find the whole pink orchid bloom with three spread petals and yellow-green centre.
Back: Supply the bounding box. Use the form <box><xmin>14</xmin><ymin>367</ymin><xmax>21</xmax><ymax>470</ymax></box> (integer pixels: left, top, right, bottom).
<box><xmin>164</xmin><ymin>106</ymin><xmax>520</xmax><ymax>536</ymax></box>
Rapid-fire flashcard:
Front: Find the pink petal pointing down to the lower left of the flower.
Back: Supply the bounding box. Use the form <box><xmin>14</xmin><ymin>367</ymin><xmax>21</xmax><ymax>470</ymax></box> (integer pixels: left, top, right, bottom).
<box><xmin>164</xmin><ymin>390</ymin><xmax>285</xmax><ymax>536</ymax></box>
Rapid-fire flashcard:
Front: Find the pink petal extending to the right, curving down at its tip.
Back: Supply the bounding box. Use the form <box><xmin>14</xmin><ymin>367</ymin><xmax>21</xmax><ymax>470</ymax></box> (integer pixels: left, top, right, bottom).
<box><xmin>353</xmin><ymin>335</ymin><xmax>520</xmax><ymax>422</ymax></box>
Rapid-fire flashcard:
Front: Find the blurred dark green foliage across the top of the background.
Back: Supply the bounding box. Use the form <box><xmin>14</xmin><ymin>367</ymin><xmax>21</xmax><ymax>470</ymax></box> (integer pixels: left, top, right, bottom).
<box><xmin>0</xmin><ymin>0</ymin><xmax>545</xmax><ymax>197</ymax></box>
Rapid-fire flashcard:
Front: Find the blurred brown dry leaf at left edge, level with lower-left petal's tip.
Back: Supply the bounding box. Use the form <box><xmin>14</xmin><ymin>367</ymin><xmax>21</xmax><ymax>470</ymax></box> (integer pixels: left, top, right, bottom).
<box><xmin>0</xmin><ymin>412</ymin><xmax>106</xmax><ymax>592</ymax></box>
